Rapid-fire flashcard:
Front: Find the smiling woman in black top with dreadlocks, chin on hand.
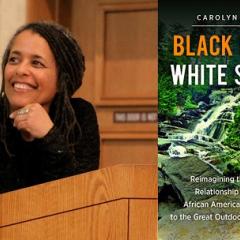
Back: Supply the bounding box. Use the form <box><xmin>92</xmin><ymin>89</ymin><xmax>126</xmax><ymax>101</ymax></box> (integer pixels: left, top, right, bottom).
<box><xmin>0</xmin><ymin>22</ymin><xmax>99</xmax><ymax>193</ymax></box>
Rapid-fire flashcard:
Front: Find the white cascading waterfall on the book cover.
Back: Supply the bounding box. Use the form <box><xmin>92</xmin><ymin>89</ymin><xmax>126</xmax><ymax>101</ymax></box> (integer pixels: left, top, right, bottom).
<box><xmin>168</xmin><ymin>92</ymin><xmax>240</xmax><ymax>160</ymax></box>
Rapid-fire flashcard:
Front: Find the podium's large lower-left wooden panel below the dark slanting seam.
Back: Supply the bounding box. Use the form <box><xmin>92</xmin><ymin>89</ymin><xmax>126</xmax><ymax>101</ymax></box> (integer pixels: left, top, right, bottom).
<box><xmin>0</xmin><ymin>200</ymin><xmax>128</xmax><ymax>240</ymax></box>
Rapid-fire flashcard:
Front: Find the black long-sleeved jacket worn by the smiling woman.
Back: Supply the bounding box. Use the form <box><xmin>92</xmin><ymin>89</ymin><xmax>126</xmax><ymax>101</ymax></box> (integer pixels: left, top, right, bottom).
<box><xmin>0</xmin><ymin>98</ymin><xmax>100</xmax><ymax>193</ymax></box>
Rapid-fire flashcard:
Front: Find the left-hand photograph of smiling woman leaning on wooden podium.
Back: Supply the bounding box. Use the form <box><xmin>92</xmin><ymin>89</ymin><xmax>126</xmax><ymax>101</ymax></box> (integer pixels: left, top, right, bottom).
<box><xmin>0</xmin><ymin>0</ymin><xmax>158</xmax><ymax>240</ymax></box>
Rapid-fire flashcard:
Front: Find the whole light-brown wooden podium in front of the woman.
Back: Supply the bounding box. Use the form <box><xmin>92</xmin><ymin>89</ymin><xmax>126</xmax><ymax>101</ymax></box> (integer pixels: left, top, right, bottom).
<box><xmin>0</xmin><ymin>165</ymin><xmax>157</xmax><ymax>240</ymax></box>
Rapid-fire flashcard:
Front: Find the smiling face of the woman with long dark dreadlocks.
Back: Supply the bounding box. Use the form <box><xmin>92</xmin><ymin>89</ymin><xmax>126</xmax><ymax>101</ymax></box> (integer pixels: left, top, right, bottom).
<box><xmin>4</xmin><ymin>30</ymin><xmax>57</xmax><ymax>111</ymax></box>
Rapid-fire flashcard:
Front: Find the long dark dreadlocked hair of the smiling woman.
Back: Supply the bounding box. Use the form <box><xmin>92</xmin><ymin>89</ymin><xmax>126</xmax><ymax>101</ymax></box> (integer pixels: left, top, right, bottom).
<box><xmin>0</xmin><ymin>22</ymin><xmax>85</xmax><ymax>156</ymax></box>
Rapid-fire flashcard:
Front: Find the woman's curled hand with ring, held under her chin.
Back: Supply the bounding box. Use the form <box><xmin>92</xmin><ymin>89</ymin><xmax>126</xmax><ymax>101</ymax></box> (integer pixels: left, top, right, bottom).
<box><xmin>9</xmin><ymin>103</ymin><xmax>53</xmax><ymax>141</ymax></box>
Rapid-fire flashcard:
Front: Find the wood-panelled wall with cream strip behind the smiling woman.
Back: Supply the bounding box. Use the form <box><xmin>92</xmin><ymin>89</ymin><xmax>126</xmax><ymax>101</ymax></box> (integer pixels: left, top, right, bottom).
<box><xmin>0</xmin><ymin>0</ymin><xmax>157</xmax><ymax>167</ymax></box>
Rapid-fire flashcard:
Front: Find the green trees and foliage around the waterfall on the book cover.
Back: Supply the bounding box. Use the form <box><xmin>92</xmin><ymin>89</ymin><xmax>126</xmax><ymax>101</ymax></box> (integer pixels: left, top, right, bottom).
<box><xmin>158</xmin><ymin>21</ymin><xmax>240</xmax><ymax>175</ymax></box>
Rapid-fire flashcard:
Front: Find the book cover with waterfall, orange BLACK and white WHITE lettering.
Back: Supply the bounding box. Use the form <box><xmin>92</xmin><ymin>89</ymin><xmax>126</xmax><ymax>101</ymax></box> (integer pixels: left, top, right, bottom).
<box><xmin>158</xmin><ymin>1</ymin><xmax>240</xmax><ymax>240</ymax></box>
